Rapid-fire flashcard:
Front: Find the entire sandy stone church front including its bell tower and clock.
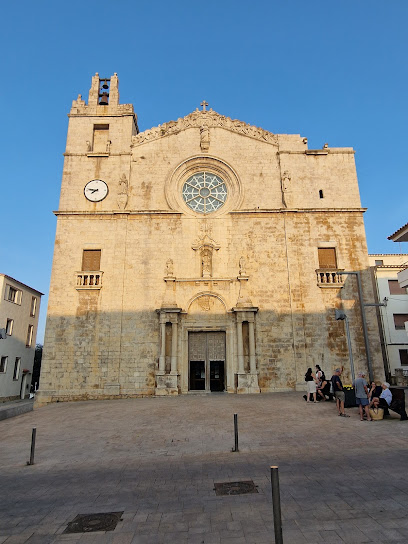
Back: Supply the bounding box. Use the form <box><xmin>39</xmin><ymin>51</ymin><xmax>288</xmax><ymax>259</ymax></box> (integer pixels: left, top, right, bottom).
<box><xmin>37</xmin><ymin>74</ymin><xmax>383</xmax><ymax>404</ymax></box>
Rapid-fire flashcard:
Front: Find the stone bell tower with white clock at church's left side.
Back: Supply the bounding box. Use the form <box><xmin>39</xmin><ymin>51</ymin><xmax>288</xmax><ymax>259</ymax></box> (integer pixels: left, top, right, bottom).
<box><xmin>37</xmin><ymin>73</ymin><xmax>139</xmax><ymax>403</ymax></box>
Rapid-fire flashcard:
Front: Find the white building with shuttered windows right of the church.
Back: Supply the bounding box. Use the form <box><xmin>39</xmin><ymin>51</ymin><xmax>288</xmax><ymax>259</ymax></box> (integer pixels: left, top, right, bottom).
<box><xmin>369</xmin><ymin>254</ymin><xmax>408</xmax><ymax>377</ymax></box>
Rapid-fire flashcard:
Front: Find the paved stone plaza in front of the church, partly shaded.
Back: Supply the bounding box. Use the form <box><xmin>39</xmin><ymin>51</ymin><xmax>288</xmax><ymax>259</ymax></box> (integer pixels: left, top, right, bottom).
<box><xmin>0</xmin><ymin>393</ymin><xmax>408</xmax><ymax>544</ymax></box>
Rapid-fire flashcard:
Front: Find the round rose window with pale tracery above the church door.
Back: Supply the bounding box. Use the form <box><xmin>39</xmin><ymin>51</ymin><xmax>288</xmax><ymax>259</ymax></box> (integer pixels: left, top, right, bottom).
<box><xmin>183</xmin><ymin>172</ymin><xmax>227</xmax><ymax>213</ymax></box>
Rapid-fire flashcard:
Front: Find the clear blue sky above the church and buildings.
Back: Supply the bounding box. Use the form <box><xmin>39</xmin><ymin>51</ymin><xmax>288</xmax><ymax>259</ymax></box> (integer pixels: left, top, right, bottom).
<box><xmin>0</xmin><ymin>0</ymin><xmax>408</xmax><ymax>341</ymax></box>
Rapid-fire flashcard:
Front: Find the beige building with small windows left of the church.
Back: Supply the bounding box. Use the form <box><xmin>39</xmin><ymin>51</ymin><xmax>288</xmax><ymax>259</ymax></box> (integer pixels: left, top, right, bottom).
<box><xmin>0</xmin><ymin>274</ymin><xmax>43</xmax><ymax>402</ymax></box>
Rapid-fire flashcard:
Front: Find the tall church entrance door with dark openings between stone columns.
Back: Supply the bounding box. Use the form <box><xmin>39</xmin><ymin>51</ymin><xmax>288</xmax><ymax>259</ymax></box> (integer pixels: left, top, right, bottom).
<box><xmin>188</xmin><ymin>331</ymin><xmax>226</xmax><ymax>392</ymax></box>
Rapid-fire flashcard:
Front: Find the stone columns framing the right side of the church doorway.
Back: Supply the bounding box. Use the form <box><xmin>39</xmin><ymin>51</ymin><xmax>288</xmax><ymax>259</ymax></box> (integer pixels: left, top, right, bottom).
<box><xmin>232</xmin><ymin>307</ymin><xmax>261</xmax><ymax>393</ymax></box>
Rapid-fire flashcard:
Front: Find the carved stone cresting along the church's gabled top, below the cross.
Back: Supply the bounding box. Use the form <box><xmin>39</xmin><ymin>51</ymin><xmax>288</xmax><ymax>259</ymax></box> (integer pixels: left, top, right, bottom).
<box><xmin>132</xmin><ymin>109</ymin><xmax>278</xmax><ymax>147</ymax></box>
